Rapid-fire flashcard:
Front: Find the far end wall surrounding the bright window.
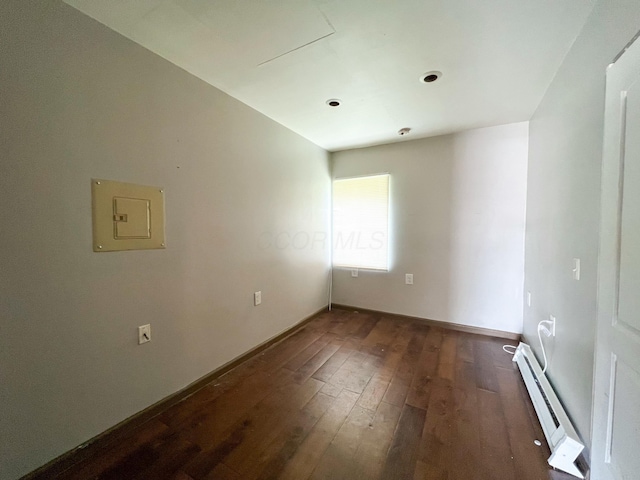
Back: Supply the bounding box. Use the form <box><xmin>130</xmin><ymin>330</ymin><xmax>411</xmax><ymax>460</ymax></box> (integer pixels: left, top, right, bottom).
<box><xmin>332</xmin><ymin>123</ymin><xmax>528</xmax><ymax>333</ymax></box>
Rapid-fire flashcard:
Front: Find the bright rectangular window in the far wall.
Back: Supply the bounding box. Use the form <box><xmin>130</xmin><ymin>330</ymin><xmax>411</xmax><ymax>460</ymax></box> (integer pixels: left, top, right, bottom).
<box><xmin>333</xmin><ymin>174</ymin><xmax>389</xmax><ymax>270</ymax></box>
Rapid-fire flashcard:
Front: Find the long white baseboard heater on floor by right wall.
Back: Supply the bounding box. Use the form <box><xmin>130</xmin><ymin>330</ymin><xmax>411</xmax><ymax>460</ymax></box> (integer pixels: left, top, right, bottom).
<box><xmin>513</xmin><ymin>343</ymin><xmax>584</xmax><ymax>478</ymax></box>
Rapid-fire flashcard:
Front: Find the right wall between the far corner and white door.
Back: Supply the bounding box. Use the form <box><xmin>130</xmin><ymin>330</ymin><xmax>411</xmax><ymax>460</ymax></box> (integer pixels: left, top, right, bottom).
<box><xmin>524</xmin><ymin>0</ymin><xmax>640</xmax><ymax>442</ymax></box>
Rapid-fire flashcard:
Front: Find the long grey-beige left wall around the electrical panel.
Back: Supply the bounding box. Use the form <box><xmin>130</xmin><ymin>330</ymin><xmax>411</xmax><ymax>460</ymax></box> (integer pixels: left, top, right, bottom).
<box><xmin>0</xmin><ymin>0</ymin><xmax>330</xmax><ymax>479</ymax></box>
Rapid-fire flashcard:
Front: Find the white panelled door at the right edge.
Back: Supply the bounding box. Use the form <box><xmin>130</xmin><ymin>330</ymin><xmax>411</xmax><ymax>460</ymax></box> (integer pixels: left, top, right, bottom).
<box><xmin>591</xmin><ymin>35</ymin><xmax>640</xmax><ymax>480</ymax></box>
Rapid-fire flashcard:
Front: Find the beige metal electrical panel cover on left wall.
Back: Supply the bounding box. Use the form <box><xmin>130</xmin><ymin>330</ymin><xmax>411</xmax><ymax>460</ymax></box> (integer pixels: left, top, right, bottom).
<box><xmin>91</xmin><ymin>180</ymin><xmax>165</xmax><ymax>252</ymax></box>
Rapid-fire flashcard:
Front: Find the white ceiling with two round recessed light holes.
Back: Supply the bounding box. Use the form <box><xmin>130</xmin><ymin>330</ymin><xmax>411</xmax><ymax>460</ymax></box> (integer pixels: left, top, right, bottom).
<box><xmin>65</xmin><ymin>0</ymin><xmax>593</xmax><ymax>151</ymax></box>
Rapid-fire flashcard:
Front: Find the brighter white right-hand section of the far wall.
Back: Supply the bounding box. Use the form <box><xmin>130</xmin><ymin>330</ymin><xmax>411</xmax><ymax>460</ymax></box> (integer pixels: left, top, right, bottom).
<box><xmin>449</xmin><ymin>123</ymin><xmax>528</xmax><ymax>333</ymax></box>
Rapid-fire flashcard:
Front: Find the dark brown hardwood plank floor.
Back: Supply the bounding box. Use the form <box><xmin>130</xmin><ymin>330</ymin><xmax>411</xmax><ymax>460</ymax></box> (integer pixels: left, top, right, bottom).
<box><xmin>48</xmin><ymin>310</ymin><xmax>552</xmax><ymax>480</ymax></box>
